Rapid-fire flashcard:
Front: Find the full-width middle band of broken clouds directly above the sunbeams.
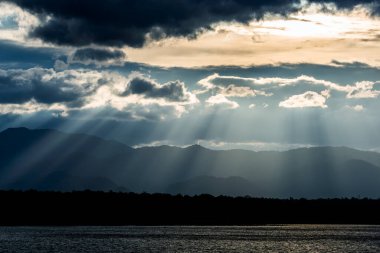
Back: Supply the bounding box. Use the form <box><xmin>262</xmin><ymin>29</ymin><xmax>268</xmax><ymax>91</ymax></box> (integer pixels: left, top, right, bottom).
<box><xmin>0</xmin><ymin>64</ymin><xmax>380</xmax><ymax>119</ymax></box>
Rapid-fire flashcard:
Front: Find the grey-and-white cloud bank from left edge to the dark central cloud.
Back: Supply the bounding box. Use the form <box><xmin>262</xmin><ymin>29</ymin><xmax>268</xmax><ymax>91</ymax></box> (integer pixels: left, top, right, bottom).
<box><xmin>0</xmin><ymin>68</ymin><xmax>198</xmax><ymax>118</ymax></box>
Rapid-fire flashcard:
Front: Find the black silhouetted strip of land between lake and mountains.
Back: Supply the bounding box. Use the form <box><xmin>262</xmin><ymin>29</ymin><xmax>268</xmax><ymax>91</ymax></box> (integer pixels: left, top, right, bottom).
<box><xmin>0</xmin><ymin>191</ymin><xmax>380</xmax><ymax>226</ymax></box>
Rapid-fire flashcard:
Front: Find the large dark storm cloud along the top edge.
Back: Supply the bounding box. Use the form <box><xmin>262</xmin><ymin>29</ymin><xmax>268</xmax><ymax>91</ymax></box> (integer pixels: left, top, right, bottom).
<box><xmin>9</xmin><ymin>0</ymin><xmax>299</xmax><ymax>47</ymax></box>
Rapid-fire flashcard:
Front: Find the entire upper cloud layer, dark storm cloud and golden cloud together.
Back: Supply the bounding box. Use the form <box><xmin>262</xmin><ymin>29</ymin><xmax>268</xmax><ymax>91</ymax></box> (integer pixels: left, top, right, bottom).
<box><xmin>0</xmin><ymin>0</ymin><xmax>380</xmax><ymax>67</ymax></box>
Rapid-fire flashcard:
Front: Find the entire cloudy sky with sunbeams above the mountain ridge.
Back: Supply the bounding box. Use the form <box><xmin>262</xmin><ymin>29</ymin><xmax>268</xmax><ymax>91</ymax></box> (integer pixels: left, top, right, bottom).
<box><xmin>0</xmin><ymin>0</ymin><xmax>380</xmax><ymax>151</ymax></box>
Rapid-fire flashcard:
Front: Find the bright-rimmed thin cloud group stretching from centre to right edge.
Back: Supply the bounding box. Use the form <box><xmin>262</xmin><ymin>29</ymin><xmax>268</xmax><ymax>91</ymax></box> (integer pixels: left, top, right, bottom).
<box><xmin>197</xmin><ymin>74</ymin><xmax>380</xmax><ymax>108</ymax></box>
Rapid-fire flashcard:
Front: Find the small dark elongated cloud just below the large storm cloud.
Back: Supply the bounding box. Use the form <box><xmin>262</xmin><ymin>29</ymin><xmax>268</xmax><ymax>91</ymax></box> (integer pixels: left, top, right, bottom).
<box><xmin>72</xmin><ymin>47</ymin><xmax>126</xmax><ymax>62</ymax></box>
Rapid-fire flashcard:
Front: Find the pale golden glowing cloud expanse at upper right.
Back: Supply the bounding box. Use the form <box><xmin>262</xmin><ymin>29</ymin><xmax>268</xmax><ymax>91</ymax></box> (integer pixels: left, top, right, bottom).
<box><xmin>126</xmin><ymin>4</ymin><xmax>380</xmax><ymax>67</ymax></box>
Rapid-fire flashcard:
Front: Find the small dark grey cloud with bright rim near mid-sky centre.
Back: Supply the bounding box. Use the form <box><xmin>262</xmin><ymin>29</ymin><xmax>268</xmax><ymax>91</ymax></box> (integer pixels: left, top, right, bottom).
<box><xmin>122</xmin><ymin>77</ymin><xmax>191</xmax><ymax>102</ymax></box>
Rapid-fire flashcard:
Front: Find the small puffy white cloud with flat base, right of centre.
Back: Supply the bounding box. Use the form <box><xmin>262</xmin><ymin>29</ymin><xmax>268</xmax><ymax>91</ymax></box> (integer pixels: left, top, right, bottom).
<box><xmin>279</xmin><ymin>91</ymin><xmax>327</xmax><ymax>108</ymax></box>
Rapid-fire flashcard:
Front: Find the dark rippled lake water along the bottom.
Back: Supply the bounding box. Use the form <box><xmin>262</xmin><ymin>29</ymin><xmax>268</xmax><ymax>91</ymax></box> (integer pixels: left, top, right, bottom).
<box><xmin>0</xmin><ymin>225</ymin><xmax>380</xmax><ymax>253</ymax></box>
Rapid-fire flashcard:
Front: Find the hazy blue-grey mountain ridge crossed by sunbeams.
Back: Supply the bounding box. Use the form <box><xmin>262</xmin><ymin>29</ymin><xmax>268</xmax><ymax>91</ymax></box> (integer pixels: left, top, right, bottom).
<box><xmin>0</xmin><ymin>128</ymin><xmax>380</xmax><ymax>198</ymax></box>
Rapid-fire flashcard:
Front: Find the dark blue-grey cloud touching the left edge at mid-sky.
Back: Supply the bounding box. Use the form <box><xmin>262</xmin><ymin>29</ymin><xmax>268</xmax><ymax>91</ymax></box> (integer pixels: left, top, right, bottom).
<box><xmin>0</xmin><ymin>68</ymin><xmax>96</xmax><ymax>104</ymax></box>
